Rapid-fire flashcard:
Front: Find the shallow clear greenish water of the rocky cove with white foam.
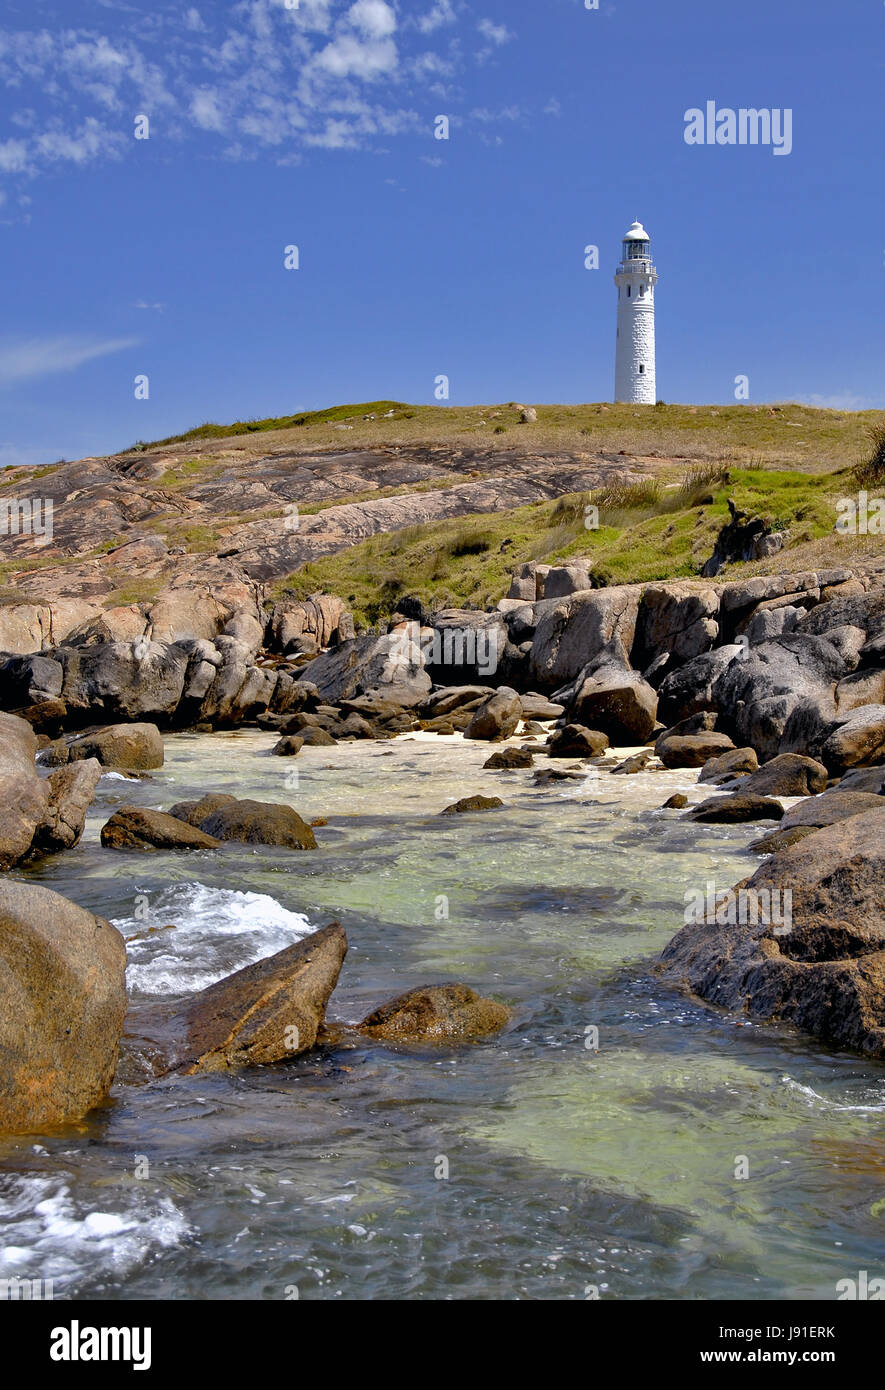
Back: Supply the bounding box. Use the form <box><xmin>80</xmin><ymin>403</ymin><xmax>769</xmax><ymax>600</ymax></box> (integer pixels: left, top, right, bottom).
<box><xmin>0</xmin><ymin>731</ymin><xmax>885</xmax><ymax>1300</ymax></box>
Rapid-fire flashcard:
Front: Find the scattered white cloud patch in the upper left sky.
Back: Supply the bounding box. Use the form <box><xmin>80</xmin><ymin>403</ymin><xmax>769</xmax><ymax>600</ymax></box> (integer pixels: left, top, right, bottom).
<box><xmin>0</xmin><ymin>0</ymin><xmax>525</xmax><ymax>183</ymax></box>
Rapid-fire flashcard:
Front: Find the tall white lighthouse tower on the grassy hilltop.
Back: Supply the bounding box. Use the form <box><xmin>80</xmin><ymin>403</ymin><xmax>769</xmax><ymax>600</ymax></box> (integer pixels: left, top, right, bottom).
<box><xmin>614</xmin><ymin>222</ymin><xmax>657</xmax><ymax>406</ymax></box>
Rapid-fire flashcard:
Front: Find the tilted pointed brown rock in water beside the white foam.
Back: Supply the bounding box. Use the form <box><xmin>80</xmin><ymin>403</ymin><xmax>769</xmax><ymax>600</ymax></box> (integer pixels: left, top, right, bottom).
<box><xmin>171</xmin><ymin>922</ymin><xmax>347</xmax><ymax>1076</ymax></box>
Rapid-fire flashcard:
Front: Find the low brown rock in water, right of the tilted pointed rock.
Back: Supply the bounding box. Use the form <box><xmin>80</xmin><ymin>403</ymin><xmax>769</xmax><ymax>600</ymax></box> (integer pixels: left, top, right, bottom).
<box><xmin>358</xmin><ymin>984</ymin><xmax>510</xmax><ymax>1043</ymax></box>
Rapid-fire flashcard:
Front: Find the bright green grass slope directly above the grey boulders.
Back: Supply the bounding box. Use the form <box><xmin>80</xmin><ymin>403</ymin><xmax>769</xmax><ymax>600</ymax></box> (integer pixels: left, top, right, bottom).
<box><xmin>274</xmin><ymin>467</ymin><xmax>847</xmax><ymax>624</ymax></box>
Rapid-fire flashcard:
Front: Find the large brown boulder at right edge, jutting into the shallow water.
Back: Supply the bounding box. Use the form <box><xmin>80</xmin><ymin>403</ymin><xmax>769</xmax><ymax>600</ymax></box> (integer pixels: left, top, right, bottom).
<box><xmin>660</xmin><ymin>812</ymin><xmax>885</xmax><ymax>1058</ymax></box>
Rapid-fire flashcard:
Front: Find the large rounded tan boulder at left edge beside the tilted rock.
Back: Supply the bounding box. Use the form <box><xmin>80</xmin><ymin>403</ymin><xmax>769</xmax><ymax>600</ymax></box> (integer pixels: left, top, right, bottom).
<box><xmin>0</xmin><ymin>880</ymin><xmax>126</xmax><ymax>1133</ymax></box>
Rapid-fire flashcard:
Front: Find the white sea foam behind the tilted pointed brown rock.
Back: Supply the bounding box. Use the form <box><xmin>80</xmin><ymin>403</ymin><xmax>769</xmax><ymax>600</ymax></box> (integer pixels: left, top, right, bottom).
<box><xmin>114</xmin><ymin>883</ymin><xmax>314</xmax><ymax>995</ymax></box>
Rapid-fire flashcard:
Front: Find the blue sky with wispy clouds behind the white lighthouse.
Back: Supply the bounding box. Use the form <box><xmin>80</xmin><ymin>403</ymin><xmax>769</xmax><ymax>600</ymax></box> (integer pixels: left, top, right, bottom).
<box><xmin>0</xmin><ymin>0</ymin><xmax>885</xmax><ymax>466</ymax></box>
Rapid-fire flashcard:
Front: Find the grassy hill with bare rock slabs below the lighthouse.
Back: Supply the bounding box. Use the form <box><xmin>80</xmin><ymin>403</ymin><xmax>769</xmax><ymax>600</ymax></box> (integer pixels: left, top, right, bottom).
<box><xmin>0</xmin><ymin>400</ymin><xmax>885</xmax><ymax>623</ymax></box>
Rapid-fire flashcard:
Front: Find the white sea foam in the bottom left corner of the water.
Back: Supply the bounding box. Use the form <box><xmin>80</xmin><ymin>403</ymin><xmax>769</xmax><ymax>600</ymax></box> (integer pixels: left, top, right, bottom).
<box><xmin>0</xmin><ymin>1173</ymin><xmax>190</xmax><ymax>1298</ymax></box>
